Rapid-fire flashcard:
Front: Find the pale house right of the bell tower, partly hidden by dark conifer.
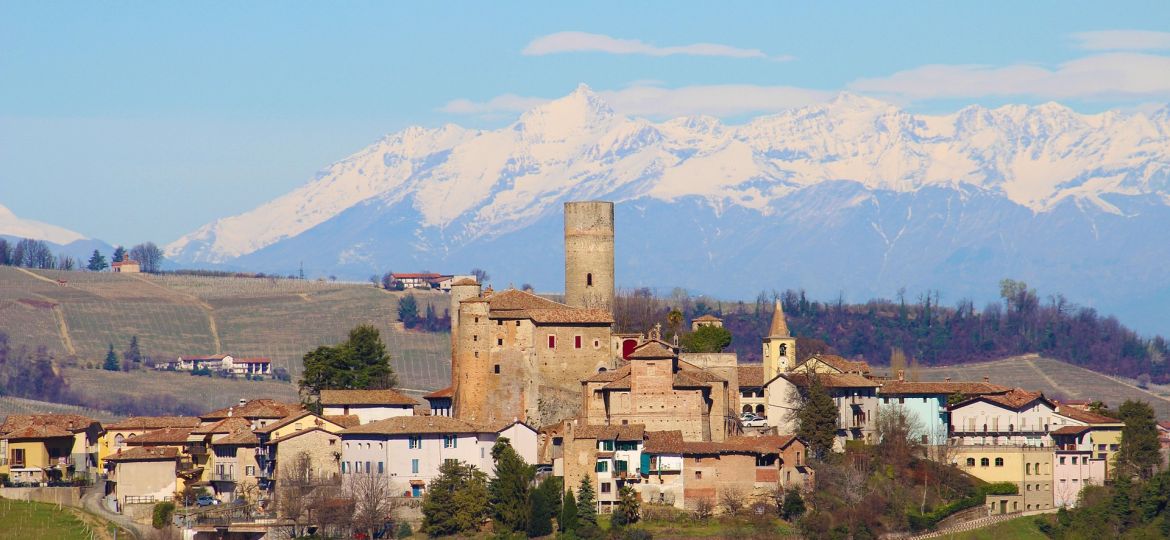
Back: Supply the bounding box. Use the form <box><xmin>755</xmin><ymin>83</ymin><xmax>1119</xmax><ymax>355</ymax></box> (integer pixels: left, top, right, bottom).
<box><xmin>764</xmin><ymin>372</ymin><xmax>879</xmax><ymax>451</ymax></box>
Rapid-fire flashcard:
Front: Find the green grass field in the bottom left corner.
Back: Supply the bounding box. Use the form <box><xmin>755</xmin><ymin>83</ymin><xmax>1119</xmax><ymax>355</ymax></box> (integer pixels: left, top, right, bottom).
<box><xmin>0</xmin><ymin>499</ymin><xmax>132</xmax><ymax>540</ymax></box>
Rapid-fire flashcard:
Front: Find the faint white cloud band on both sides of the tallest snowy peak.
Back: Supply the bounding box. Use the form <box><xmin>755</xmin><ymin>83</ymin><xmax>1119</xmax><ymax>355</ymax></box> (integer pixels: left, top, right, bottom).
<box><xmin>441</xmin><ymin>84</ymin><xmax>832</xmax><ymax>118</ymax></box>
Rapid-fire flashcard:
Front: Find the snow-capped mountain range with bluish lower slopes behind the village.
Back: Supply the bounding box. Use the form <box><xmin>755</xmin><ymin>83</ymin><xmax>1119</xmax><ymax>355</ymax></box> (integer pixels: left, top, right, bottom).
<box><xmin>166</xmin><ymin>85</ymin><xmax>1170</xmax><ymax>334</ymax></box>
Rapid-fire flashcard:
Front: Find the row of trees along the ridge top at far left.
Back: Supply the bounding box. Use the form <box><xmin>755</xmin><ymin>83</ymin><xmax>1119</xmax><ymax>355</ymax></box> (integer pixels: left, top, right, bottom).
<box><xmin>0</xmin><ymin>238</ymin><xmax>163</xmax><ymax>274</ymax></box>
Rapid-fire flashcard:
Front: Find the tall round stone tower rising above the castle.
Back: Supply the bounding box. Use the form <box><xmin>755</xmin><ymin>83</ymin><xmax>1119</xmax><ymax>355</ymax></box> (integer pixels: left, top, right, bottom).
<box><xmin>565</xmin><ymin>201</ymin><xmax>613</xmax><ymax>312</ymax></box>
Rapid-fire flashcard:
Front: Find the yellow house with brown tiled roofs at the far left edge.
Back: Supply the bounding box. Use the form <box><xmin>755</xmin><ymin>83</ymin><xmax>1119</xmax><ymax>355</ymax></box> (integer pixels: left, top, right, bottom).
<box><xmin>0</xmin><ymin>414</ymin><xmax>102</xmax><ymax>483</ymax></box>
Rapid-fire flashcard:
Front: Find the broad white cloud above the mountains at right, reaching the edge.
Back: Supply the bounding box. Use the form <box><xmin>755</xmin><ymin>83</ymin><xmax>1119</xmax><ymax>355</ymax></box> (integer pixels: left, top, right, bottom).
<box><xmin>849</xmin><ymin>53</ymin><xmax>1170</xmax><ymax>101</ymax></box>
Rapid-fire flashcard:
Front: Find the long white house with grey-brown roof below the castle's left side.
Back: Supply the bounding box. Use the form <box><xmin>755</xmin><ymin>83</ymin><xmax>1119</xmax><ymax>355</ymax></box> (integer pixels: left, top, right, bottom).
<box><xmin>339</xmin><ymin>416</ymin><xmax>536</xmax><ymax>497</ymax></box>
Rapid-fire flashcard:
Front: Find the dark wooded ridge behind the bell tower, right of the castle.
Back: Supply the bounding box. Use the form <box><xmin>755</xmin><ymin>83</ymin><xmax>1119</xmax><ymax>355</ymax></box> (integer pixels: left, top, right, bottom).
<box><xmin>615</xmin><ymin>281</ymin><xmax>1170</xmax><ymax>383</ymax></box>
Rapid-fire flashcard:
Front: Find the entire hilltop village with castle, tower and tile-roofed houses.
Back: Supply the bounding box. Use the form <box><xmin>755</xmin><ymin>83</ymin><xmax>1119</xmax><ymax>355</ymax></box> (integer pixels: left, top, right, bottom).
<box><xmin>0</xmin><ymin>201</ymin><xmax>1170</xmax><ymax>539</ymax></box>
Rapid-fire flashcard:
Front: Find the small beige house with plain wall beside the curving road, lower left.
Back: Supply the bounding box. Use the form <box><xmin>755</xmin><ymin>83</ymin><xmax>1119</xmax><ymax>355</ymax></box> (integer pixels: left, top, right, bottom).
<box><xmin>106</xmin><ymin>446</ymin><xmax>179</xmax><ymax>512</ymax></box>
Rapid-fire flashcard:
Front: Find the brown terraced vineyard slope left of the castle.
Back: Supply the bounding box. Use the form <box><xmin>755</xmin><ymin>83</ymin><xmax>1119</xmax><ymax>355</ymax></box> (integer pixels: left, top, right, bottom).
<box><xmin>0</xmin><ymin>266</ymin><xmax>450</xmax><ymax>390</ymax></box>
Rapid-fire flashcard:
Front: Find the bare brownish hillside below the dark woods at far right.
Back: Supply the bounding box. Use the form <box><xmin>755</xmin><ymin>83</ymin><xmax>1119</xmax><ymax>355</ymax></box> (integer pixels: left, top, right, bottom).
<box><xmin>920</xmin><ymin>355</ymin><xmax>1170</xmax><ymax>418</ymax></box>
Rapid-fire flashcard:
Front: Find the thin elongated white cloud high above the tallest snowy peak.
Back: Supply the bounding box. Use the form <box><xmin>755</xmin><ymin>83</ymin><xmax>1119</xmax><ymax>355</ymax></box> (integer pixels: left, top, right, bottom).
<box><xmin>522</xmin><ymin>32</ymin><xmax>792</xmax><ymax>61</ymax></box>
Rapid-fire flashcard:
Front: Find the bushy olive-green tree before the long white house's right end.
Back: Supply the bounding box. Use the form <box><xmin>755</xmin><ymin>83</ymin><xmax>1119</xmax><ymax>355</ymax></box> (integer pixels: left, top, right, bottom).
<box><xmin>422</xmin><ymin>461</ymin><xmax>488</xmax><ymax>538</ymax></box>
